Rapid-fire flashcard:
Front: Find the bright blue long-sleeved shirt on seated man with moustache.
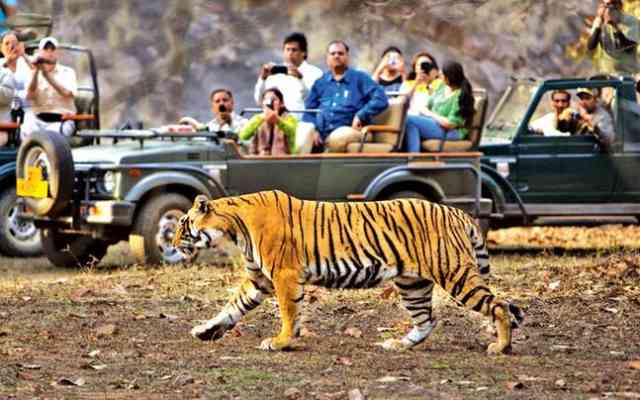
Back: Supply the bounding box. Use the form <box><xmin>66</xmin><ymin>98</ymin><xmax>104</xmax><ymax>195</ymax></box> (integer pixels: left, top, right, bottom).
<box><xmin>302</xmin><ymin>68</ymin><xmax>389</xmax><ymax>139</ymax></box>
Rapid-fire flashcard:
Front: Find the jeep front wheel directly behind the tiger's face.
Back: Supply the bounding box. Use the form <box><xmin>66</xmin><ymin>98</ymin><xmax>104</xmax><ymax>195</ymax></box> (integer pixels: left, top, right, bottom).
<box><xmin>129</xmin><ymin>193</ymin><xmax>195</xmax><ymax>265</ymax></box>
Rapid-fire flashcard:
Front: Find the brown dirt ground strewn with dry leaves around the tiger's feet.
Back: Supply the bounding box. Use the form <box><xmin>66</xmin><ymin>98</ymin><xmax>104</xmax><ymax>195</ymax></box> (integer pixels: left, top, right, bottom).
<box><xmin>0</xmin><ymin>226</ymin><xmax>640</xmax><ymax>400</ymax></box>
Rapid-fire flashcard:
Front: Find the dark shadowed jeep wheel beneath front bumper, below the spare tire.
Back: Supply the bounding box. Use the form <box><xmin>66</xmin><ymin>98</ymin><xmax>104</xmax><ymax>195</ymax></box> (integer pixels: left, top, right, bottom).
<box><xmin>41</xmin><ymin>228</ymin><xmax>109</xmax><ymax>268</ymax></box>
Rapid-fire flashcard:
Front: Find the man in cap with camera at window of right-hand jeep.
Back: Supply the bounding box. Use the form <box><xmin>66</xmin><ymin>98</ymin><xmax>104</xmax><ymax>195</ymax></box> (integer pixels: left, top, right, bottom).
<box><xmin>576</xmin><ymin>88</ymin><xmax>614</xmax><ymax>146</ymax></box>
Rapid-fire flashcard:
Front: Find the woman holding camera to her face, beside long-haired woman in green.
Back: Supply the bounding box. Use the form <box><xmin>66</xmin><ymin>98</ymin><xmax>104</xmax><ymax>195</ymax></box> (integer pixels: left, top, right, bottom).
<box><xmin>400</xmin><ymin>51</ymin><xmax>444</xmax><ymax>115</ymax></box>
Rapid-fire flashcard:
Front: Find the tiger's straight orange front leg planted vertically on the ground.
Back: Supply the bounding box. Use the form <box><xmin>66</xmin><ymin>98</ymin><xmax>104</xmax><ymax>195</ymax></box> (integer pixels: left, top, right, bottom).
<box><xmin>260</xmin><ymin>269</ymin><xmax>304</xmax><ymax>350</ymax></box>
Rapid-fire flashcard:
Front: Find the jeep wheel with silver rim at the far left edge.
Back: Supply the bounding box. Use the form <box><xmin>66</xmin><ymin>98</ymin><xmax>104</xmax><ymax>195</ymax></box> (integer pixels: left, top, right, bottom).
<box><xmin>0</xmin><ymin>189</ymin><xmax>42</xmax><ymax>257</ymax></box>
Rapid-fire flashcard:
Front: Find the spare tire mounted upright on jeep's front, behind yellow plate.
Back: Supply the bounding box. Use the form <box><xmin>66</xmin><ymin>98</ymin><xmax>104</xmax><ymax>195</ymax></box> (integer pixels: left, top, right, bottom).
<box><xmin>16</xmin><ymin>132</ymin><xmax>74</xmax><ymax>217</ymax></box>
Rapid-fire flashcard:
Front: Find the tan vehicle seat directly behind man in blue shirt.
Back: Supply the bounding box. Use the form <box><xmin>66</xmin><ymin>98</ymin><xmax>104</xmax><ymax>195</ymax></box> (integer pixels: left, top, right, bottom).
<box><xmin>347</xmin><ymin>95</ymin><xmax>409</xmax><ymax>153</ymax></box>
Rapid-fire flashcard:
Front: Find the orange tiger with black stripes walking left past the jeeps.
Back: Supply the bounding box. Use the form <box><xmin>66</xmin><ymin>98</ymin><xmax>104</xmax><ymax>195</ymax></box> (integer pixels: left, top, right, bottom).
<box><xmin>173</xmin><ymin>190</ymin><xmax>524</xmax><ymax>354</ymax></box>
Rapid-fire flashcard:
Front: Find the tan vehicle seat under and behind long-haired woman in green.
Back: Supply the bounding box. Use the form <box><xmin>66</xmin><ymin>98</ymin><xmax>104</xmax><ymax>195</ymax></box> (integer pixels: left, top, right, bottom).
<box><xmin>422</xmin><ymin>89</ymin><xmax>489</xmax><ymax>152</ymax></box>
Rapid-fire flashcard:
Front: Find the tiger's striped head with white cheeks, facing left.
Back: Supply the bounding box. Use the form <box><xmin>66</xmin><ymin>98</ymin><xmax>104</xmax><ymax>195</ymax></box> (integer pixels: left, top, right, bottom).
<box><xmin>172</xmin><ymin>195</ymin><xmax>229</xmax><ymax>257</ymax></box>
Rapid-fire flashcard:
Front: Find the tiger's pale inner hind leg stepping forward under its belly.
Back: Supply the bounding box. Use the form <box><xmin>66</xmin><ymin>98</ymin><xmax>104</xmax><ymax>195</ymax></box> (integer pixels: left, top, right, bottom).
<box><xmin>381</xmin><ymin>277</ymin><xmax>437</xmax><ymax>351</ymax></box>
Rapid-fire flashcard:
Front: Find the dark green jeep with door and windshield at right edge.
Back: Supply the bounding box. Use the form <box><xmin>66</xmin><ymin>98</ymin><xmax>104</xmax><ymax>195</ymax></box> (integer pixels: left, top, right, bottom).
<box><xmin>480</xmin><ymin>77</ymin><xmax>640</xmax><ymax>227</ymax></box>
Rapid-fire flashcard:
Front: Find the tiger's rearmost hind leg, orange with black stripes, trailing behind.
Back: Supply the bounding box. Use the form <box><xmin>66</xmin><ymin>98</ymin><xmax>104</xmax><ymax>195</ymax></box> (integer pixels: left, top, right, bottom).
<box><xmin>444</xmin><ymin>264</ymin><xmax>523</xmax><ymax>354</ymax></box>
